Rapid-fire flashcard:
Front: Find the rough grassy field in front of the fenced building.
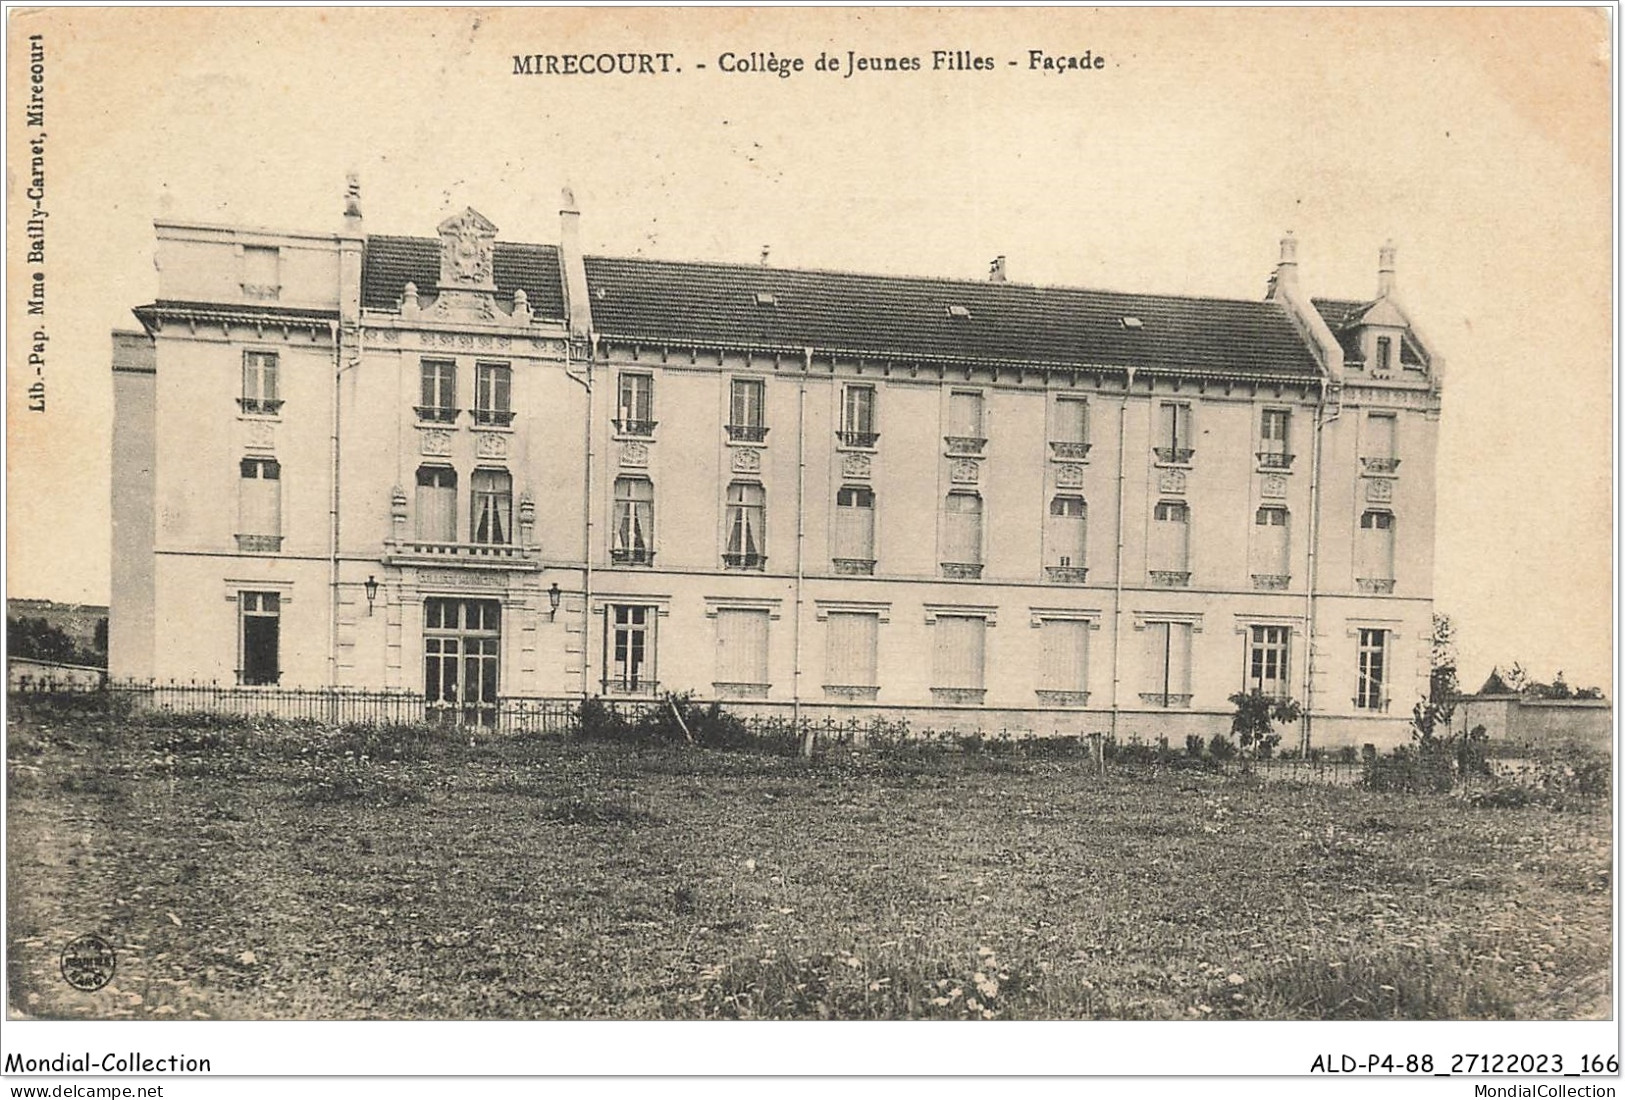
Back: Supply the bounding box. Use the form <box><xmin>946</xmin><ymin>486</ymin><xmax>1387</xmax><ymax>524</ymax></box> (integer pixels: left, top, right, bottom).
<box><xmin>7</xmin><ymin>707</ymin><xmax>1612</xmax><ymax>1019</ymax></box>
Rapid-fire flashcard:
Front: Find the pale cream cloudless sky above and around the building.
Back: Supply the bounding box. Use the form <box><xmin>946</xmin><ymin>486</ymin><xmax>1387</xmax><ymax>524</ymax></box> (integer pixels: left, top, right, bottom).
<box><xmin>7</xmin><ymin>8</ymin><xmax>1615</xmax><ymax>695</ymax></box>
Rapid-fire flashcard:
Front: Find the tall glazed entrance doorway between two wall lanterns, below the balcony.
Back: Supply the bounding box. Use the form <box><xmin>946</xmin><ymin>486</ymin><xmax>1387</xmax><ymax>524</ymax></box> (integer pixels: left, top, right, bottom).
<box><xmin>423</xmin><ymin>596</ymin><xmax>502</xmax><ymax>726</ymax></box>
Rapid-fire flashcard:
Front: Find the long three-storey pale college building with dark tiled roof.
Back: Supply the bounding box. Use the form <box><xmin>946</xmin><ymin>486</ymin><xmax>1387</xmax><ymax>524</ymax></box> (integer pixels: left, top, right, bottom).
<box><xmin>111</xmin><ymin>184</ymin><xmax>1441</xmax><ymax>746</ymax></box>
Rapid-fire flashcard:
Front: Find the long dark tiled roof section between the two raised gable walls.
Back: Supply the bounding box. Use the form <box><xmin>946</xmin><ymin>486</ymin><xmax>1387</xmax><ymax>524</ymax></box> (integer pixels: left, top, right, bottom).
<box><xmin>585</xmin><ymin>257</ymin><xmax>1318</xmax><ymax>377</ymax></box>
